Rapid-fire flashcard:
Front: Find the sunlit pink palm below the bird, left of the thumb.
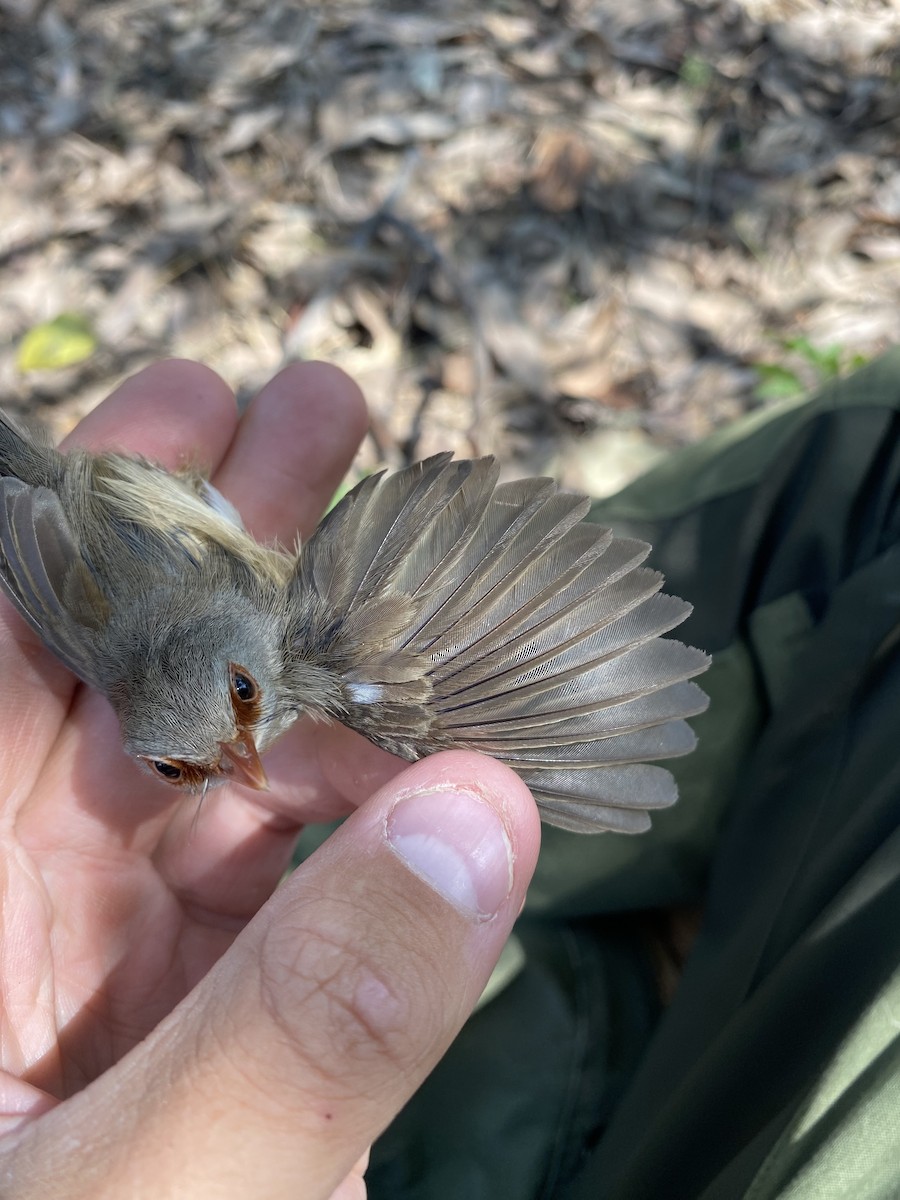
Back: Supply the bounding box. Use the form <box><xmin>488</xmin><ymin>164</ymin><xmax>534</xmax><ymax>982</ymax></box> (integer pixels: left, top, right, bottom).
<box><xmin>0</xmin><ymin>672</ymin><xmax>240</xmax><ymax>1097</ymax></box>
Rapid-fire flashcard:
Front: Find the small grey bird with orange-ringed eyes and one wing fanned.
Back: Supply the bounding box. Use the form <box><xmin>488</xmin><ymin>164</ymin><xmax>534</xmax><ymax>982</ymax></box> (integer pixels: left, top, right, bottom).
<box><xmin>0</xmin><ymin>418</ymin><xmax>708</xmax><ymax>833</ymax></box>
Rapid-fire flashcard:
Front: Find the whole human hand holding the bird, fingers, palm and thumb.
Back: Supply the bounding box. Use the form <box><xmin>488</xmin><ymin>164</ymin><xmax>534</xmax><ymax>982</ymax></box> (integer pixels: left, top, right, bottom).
<box><xmin>0</xmin><ymin>362</ymin><xmax>539</xmax><ymax>1200</ymax></box>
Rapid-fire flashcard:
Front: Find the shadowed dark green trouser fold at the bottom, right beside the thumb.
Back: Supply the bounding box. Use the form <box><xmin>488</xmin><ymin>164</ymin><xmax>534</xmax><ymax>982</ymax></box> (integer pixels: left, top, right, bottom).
<box><xmin>366</xmin><ymin>920</ymin><xmax>659</xmax><ymax>1200</ymax></box>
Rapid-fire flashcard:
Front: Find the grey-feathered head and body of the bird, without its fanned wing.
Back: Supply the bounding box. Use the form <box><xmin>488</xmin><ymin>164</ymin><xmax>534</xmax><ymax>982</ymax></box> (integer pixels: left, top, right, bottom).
<box><xmin>0</xmin><ymin>416</ymin><xmax>295</xmax><ymax>786</ymax></box>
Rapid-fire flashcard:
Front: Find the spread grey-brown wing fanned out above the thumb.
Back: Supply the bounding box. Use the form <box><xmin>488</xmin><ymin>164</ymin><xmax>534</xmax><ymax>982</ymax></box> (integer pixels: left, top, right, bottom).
<box><xmin>294</xmin><ymin>455</ymin><xmax>708</xmax><ymax>833</ymax></box>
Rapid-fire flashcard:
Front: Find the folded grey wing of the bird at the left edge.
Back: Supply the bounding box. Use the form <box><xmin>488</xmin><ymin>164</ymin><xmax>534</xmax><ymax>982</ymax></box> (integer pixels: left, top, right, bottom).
<box><xmin>0</xmin><ymin>478</ymin><xmax>109</xmax><ymax>684</ymax></box>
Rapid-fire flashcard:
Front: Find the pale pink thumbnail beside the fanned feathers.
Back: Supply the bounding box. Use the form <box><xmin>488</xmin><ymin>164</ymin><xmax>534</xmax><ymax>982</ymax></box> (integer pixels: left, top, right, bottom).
<box><xmin>385</xmin><ymin>791</ymin><xmax>512</xmax><ymax>919</ymax></box>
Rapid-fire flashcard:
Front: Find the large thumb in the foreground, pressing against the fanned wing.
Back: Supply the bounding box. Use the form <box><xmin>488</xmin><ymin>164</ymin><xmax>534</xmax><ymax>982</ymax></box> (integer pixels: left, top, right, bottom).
<box><xmin>19</xmin><ymin>751</ymin><xmax>540</xmax><ymax>1200</ymax></box>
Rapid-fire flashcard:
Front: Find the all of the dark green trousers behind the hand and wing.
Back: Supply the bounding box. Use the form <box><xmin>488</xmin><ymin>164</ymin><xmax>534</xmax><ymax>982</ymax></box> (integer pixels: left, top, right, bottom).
<box><xmin>368</xmin><ymin>353</ymin><xmax>900</xmax><ymax>1200</ymax></box>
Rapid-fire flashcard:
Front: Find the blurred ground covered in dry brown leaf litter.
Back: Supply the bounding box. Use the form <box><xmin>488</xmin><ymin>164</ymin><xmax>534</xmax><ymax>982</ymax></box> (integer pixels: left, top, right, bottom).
<box><xmin>0</xmin><ymin>0</ymin><xmax>900</xmax><ymax>494</ymax></box>
